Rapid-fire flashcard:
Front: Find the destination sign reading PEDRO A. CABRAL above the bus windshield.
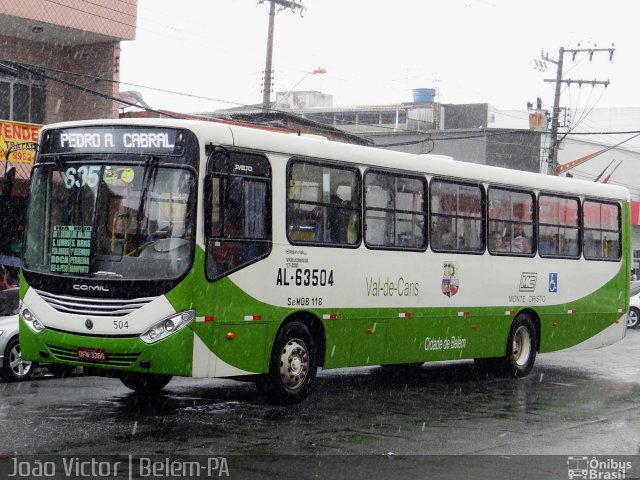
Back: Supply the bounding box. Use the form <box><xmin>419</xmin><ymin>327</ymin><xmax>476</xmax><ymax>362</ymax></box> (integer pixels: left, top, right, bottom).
<box><xmin>42</xmin><ymin>126</ymin><xmax>183</xmax><ymax>155</ymax></box>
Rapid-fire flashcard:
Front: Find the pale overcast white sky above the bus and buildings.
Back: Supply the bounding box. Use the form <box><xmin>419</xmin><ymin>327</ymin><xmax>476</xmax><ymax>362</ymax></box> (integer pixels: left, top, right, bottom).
<box><xmin>120</xmin><ymin>0</ymin><xmax>640</xmax><ymax>113</ymax></box>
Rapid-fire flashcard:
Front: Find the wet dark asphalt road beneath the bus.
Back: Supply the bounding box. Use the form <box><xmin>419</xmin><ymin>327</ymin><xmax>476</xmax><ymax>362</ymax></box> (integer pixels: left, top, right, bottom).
<box><xmin>0</xmin><ymin>330</ymin><xmax>640</xmax><ymax>478</ymax></box>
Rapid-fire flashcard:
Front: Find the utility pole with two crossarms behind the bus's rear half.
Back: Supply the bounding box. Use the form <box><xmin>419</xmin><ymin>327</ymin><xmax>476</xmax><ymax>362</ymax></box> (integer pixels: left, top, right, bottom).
<box><xmin>541</xmin><ymin>47</ymin><xmax>615</xmax><ymax>175</ymax></box>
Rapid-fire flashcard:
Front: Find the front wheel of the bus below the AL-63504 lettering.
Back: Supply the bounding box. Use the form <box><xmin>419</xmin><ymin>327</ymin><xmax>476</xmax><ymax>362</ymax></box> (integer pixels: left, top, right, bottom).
<box><xmin>256</xmin><ymin>321</ymin><xmax>318</xmax><ymax>405</ymax></box>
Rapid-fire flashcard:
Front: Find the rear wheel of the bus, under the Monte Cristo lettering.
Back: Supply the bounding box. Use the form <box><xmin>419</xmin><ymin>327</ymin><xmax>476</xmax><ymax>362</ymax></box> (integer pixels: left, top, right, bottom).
<box><xmin>504</xmin><ymin>313</ymin><xmax>538</xmax><ymax>378</ymax></box>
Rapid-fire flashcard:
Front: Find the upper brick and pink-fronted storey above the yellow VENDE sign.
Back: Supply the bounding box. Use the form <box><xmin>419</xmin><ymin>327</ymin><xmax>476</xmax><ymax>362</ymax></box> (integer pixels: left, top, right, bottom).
<box><xmin>0</xmin><ymin>0</ymin><xmax>137</xmax><ymax>123</ymax></box>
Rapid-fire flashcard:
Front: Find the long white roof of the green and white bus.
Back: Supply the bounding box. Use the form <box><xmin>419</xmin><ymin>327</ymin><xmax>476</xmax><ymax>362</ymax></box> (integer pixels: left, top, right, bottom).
<box><xmin>40</xmin><ymin>118</ymin><xmax>630</xmax><ymax>202</ymax></box>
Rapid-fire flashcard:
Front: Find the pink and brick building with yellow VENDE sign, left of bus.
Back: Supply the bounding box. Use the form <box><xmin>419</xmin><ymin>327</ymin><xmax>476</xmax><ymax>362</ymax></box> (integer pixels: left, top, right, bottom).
<box><xmin>0</xmin><ymin>0</ymin><xmax>137</xmax><ymax>279</ymax></box>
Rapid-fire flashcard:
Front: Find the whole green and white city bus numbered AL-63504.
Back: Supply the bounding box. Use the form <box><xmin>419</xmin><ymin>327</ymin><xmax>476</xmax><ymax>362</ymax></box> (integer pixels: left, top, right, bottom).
<box><xmin>20</xmin><ymin>119</ymin><xmax>631</xmax><ymax>403</ymax></box>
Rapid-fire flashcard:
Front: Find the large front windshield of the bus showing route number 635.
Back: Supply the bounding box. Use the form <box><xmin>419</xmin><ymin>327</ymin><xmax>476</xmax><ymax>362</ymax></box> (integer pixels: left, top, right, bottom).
<box><xmin>24</xmin><ymin>162</ymin><xmax>195</xmax><ymax>280</ymax></box>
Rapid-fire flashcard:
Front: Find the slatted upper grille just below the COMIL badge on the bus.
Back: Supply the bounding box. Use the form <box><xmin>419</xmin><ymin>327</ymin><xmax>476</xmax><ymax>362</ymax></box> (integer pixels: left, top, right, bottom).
<box><xmin>36</xmin><ymin>290</ymin><xmax>158</xmax><ymax>317</ymax></box>
